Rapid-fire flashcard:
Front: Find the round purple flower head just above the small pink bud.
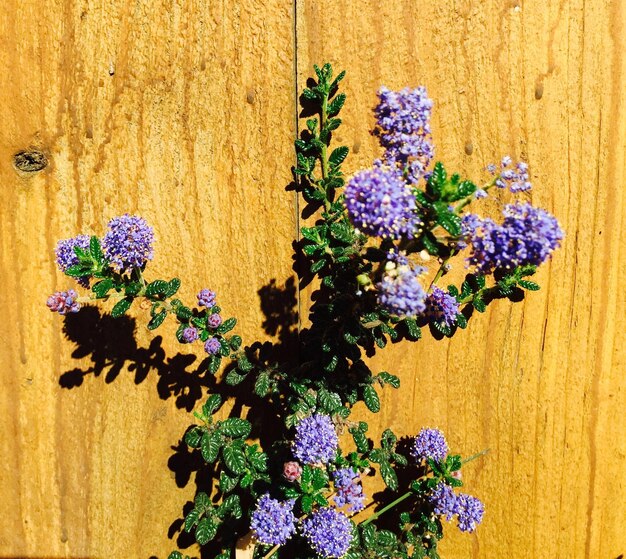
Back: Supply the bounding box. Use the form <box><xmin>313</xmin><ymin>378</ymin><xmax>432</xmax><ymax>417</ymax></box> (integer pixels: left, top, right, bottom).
<box><xmin>291</xmin><ymin>413</ymin><xmax>339</xmax><ymax>464</ymax></box>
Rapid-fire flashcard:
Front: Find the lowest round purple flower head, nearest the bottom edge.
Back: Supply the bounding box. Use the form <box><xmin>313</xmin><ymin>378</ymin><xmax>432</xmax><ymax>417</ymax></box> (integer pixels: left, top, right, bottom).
<box><xmin>302</xmin><ymin>507</ymin><xmax>354</xmax><ymax>557</ymax></box>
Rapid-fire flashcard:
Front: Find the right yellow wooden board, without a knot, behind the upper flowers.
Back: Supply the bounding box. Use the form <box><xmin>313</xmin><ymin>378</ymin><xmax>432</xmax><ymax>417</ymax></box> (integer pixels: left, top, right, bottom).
<box><xmin>296</xmin><ymin>0</ymin><xmax>626</xmax><ymax>559</ymax></box>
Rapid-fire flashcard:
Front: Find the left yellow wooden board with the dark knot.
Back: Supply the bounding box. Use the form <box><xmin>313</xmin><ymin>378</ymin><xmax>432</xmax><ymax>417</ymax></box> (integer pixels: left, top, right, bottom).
<box><xmin>0</xmin><ymin>0</ymin><xmax>296</xmax><ymax>558</ymax></box>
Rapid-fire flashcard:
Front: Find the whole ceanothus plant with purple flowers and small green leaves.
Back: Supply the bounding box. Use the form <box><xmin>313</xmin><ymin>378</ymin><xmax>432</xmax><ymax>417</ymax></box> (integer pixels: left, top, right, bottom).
<box><xmin>47</xmin><ymin>64</ymin><xmax>563</xmax><ymax>559</ymax></box>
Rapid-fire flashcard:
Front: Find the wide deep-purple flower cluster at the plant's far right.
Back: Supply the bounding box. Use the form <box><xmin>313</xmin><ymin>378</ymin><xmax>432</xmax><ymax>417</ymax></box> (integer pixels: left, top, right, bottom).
<box><xmin>468</xmin><ymin>203</ymin><xmax>563</xmax><ymax>273</ymax></box>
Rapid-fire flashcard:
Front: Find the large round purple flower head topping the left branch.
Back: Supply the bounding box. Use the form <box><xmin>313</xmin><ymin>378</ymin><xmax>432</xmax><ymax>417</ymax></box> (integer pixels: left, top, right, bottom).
<box><xmin>102</xmin><ymin>214</ymin><xmax>154</xmax><ymax>273</ymax></box>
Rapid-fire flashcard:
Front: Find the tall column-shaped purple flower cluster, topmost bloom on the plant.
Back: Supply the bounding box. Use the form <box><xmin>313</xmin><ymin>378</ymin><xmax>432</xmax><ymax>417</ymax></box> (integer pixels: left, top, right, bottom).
<box><xmin>373</xmin><ymin>87</ymin><xmax>434</xmax><ymax>182</ymax></box>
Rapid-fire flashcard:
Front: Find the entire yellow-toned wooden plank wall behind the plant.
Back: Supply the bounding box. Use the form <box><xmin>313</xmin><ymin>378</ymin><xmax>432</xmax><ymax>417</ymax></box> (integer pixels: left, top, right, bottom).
<box><xmin>0</xmin><ymin>0</ymin><xmax>626</xmax><ymax>559</ymax></box>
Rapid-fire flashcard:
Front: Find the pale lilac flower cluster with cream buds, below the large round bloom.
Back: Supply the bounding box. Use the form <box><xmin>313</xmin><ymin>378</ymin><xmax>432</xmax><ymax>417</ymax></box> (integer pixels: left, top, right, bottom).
<box><xmin>376</xmin><ymin>259</ymin><xmax>426</xmax><ymax>316</ymax></box>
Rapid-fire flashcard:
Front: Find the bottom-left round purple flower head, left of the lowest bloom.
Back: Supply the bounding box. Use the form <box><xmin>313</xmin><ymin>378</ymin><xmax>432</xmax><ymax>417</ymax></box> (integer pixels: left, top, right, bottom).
<box><xmin>250</xmin><ymin>493</ymin><xmax>296</xmax><ymax>545</ymax></box>
